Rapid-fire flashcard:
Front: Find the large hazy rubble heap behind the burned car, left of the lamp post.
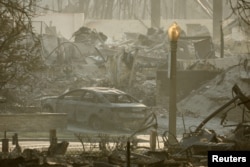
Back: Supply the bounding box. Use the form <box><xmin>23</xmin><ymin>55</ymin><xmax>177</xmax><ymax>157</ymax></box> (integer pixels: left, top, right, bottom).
<box><xmin>0</xmin><ymin>27</ymin><xmax>172</xmax><ymax>109</ymax></box>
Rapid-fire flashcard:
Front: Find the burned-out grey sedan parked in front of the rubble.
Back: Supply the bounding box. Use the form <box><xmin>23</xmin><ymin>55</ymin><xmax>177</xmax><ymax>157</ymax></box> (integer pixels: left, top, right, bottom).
<box><xmin>41</xmin><ymin>87</ymin><xmax>150</xmax><ymax>129</ymax></box>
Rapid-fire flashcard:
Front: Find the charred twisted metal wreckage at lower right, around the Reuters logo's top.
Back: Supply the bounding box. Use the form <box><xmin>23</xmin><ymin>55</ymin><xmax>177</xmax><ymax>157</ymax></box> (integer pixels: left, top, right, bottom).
<box><xmin>162</xmin><ymin>84</ymin><xmax>250</xmax><ymax>159</ymax></box>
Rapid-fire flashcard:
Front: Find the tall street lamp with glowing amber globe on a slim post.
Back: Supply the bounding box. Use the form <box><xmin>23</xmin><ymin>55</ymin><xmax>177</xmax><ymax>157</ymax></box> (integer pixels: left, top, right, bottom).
<box><xmin>168</xmin><ymin>23</ymin><xmax>181</xmax><ymax>142</ymax></box>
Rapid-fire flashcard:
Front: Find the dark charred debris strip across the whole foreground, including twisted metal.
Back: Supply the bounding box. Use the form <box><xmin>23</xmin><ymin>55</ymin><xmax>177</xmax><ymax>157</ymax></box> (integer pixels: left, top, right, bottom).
<box><xmin>0</xmin><ymin>84</ymin><xmax>250</xmax><ymax>167</ymax></box>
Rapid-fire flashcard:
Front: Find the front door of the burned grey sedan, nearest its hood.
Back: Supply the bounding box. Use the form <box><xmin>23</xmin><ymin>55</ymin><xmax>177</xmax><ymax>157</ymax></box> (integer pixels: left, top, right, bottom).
<box><xmin>56</xmin><ymin>90</ymin><xmax>83</xmax><ymax>121</ymax></box>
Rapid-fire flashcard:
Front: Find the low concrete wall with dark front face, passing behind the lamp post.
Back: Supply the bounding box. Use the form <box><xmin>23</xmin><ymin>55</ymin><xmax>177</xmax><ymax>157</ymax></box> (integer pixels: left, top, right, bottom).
<box><xmin>156</xmin><ymin>55</ymin><xmax>249</xmax><ymax>105</ymax></box>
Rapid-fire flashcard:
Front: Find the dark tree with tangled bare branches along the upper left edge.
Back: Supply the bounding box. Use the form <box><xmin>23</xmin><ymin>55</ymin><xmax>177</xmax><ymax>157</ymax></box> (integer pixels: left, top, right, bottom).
<box><xmin>0</xmin><ymin>1</ymin><xmax>41</xmax><ymax>89</ymax></box>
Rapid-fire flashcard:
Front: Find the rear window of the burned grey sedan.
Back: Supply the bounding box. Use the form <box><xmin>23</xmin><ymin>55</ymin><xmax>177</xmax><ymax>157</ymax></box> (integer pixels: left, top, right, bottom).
<box><xmin>103</xmin><ymin>94</ymin><xmax>138</xmax><ymax>103</ymax></box>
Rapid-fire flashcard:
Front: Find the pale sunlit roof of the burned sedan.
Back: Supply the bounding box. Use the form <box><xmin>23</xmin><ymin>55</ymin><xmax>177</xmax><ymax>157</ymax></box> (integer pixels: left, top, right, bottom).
<box><xmin>80</xmin><ymin>87</ymin><xmax>126</xmax><ymax>94</ymax></box>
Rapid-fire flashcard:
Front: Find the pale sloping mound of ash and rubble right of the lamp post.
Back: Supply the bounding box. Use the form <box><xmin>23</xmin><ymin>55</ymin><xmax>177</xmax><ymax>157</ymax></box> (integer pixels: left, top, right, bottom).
<box><xmin>177</xmin><ymin>62</ymin><xmax>250</xmax><ymax>121</ymax></box>
